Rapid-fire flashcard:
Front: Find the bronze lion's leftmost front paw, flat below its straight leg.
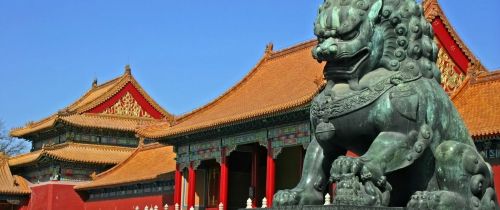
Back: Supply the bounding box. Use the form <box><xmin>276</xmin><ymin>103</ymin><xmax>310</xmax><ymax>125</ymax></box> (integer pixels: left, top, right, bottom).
<box><xmin>273</xmin><ymin>188</ymin><xmax>323</xmax><ymax>206</ymax></box>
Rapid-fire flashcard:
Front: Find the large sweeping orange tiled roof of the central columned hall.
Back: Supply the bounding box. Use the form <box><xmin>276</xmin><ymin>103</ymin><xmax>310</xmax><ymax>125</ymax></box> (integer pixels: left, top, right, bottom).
<box><xmin>137</xmin><ymin>41</ymin><xmax>324</xmax><ymax>138</ymax></box>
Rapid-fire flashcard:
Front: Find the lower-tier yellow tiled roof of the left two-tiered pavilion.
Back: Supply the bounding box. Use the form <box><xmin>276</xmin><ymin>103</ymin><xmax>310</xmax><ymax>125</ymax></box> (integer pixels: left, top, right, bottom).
<box><xmin>9</xmin><ymin>142</ymin><xmax>134</xmax><ymax>167</ymax></box>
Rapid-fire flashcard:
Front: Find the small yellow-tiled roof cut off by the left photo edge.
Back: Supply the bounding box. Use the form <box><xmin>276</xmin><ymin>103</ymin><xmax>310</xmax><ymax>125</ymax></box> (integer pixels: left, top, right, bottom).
<box><xmin>0</xmin><ymin>153</ymin><xmax>31</xmax><ymax>195</ymax></box>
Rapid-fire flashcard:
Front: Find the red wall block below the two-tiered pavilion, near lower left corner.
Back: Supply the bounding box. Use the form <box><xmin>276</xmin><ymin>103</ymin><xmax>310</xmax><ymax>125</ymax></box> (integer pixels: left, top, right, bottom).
<box><xmin>20</xmin><ymin>182</ymin><xmax>84</xmax><ymax>210</ymax></box>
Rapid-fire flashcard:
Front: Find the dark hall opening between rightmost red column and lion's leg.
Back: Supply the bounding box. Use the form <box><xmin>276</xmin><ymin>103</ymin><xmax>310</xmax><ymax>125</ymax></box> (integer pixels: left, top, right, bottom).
<box><xmin>275</xmin><ymin>145</ymin><xmax>305</xmax><ymax>191</ymax></box>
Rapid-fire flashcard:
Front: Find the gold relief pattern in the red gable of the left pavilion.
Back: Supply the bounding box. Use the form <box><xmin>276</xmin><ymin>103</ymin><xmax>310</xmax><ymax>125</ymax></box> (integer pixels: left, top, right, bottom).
<box><xmin>103</xmin><ymin>92</ymin><xmax>151</xmax><ymax>118</ymax></box>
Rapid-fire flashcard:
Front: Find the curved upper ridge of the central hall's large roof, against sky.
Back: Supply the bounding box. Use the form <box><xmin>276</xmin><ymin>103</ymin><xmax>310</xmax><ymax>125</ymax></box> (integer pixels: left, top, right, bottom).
<box><xmin>174</xmin><ymin>45</ymin><xmax>272</xmax><ymax>125</ymax></box>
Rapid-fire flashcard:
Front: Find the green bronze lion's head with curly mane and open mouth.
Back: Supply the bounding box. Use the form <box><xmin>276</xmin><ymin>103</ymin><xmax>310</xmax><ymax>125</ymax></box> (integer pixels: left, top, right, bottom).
<box><xmin>313</xmin><ymin>0</ymin><xmax>439</xmax><ymax>81</ymax></box>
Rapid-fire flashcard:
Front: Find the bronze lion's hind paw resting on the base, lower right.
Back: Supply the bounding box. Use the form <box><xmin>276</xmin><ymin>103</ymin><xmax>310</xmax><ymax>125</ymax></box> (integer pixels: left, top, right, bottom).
<box><xmin>407</xmin><ymin>191</ymin><xmax>468</xmax><ymax>210</ymax></box>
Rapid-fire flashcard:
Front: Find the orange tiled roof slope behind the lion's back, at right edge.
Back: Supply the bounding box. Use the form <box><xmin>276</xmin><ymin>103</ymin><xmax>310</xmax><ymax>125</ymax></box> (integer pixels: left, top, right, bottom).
<box><xmin>451</xmin><ymin>71</ymin><xmax>500</xmax><ymax>139</ymax></box>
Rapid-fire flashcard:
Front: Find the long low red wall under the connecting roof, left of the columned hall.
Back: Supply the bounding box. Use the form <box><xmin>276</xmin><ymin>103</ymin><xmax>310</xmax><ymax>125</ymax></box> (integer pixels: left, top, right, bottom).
<box><xmin>85</xmin><ymin>194</ymin><xmax>173</xmax><ymax>210</ymax></box>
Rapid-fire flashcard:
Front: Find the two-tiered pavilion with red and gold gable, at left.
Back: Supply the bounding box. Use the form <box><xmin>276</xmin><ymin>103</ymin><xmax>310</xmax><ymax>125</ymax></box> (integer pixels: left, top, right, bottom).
<box><xmin>9</xmin><ymin>66</ymin><xmax>173</xmax><ymax>183</ymax></box>
